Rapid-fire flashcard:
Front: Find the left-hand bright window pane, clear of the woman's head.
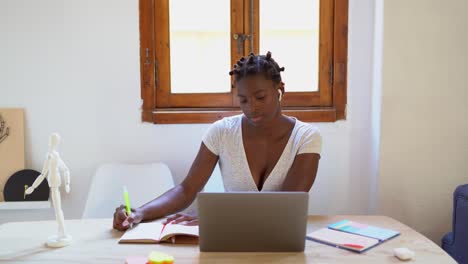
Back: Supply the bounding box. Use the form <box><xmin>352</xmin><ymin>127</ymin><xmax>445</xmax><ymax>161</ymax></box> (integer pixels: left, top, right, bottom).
<box><xmin>169</xmin><ymin>0</ymin><xmax>231</xmax><ymax>93</ymax></box>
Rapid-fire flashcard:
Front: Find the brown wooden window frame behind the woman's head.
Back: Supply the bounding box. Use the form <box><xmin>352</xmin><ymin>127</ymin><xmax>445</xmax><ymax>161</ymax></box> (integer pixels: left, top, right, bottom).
<box><xmin>139</xmin><ymin>0</ymin><xmax>348</xmax><ymax>124</ymax></box>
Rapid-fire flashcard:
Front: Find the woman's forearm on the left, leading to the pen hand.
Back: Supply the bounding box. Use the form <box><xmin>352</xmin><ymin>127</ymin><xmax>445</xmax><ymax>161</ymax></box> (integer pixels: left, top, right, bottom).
<box><xmin>138</xmin><ymin>185</ymin><xmax>195</xmax><ymax>221</ymax></box>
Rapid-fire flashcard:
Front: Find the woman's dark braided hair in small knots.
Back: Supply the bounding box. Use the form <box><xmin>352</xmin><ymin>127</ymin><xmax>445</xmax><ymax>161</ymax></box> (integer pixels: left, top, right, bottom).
<box><xmin>229</xmin><ymin>51</ymin><xmax>284</xmax><ymax>84</ymax></box>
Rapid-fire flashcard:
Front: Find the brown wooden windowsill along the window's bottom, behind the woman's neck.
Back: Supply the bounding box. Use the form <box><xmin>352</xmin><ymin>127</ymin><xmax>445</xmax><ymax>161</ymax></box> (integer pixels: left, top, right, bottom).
<box><xmin>142</xmin><ymin>107</ymin><xmax>345</xmax><ymax>124</ymax></box>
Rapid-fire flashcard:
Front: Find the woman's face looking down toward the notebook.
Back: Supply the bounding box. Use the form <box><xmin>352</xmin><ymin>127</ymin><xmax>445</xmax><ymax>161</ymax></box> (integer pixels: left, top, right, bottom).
<box><xmin>236</xmin><ymin>75</ymin><xmax>281</xmax><ymax>125</ymax></box>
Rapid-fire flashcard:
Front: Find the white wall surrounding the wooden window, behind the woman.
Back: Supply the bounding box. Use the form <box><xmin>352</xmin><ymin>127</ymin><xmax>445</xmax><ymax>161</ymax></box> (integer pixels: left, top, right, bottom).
<box><xmin>0</xmin><ymin>0</ymin><xmax>376</xmax><ymax>225</ymax></box>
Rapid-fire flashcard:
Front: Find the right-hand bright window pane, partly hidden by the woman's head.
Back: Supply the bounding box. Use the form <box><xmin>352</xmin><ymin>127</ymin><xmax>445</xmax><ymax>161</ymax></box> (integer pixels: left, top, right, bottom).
<box><xmin>259</xmin><ymin>0</ymin><xmax>320</xmax><ymax>92</ymax></box>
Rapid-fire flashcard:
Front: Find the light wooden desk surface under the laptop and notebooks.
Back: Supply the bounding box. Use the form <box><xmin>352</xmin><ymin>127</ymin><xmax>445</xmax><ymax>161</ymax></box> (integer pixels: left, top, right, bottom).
<box><xmin>0</xmin><ymin>215</ymin><xmax>456</xmax><ymax>263</ymax></box>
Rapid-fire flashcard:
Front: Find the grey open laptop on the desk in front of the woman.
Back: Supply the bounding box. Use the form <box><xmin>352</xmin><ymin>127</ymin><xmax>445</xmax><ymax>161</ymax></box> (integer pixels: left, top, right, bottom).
<box><xmin>197</xmin><ymin>192</ymin><xmax>309</xmax><ymax>252</ymax></box>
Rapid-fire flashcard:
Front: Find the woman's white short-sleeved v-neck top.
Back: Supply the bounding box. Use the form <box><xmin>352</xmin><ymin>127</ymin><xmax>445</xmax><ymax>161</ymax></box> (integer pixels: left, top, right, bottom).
<box><xmin>203</xmin><ymin>114</ymin><xmax>322</xmax><ymax>192</ymax></box>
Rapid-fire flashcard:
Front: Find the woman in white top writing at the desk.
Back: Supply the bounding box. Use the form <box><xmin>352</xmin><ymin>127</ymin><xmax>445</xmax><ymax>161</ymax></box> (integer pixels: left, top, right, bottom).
<box><xmin>114</xmin><ymin>52</ymin><xmax>321</xmax><ymax>230</ymax></box>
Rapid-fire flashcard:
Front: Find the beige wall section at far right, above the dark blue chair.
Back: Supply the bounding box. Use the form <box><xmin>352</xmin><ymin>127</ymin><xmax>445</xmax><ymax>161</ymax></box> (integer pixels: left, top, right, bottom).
<box><xmin>379</xmin><ymin>0</ymin><xmax>468</xmax><ymax>242</ymax></box>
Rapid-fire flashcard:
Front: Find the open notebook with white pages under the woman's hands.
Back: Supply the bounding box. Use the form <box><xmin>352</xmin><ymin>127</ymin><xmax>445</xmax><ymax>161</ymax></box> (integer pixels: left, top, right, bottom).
<box><xmin>119</xmin><ymin>222</ymin><xmax>198</xmax><ymax>244</ymax></box>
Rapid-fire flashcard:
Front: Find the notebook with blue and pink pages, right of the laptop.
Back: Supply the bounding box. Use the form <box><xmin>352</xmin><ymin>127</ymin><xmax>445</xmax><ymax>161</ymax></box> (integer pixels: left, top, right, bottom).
<box><xmin>307</xmin><ymin>220</ymin><xmax>400</xmax><ymax>253</ymax></box>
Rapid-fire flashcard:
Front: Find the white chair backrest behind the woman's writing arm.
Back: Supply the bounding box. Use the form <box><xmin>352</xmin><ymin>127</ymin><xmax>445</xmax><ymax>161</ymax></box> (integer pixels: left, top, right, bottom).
<box><xmin>82</xmin><ymin>163</ymin><xmax>174</xmax><ymax>218</ymax></box>
